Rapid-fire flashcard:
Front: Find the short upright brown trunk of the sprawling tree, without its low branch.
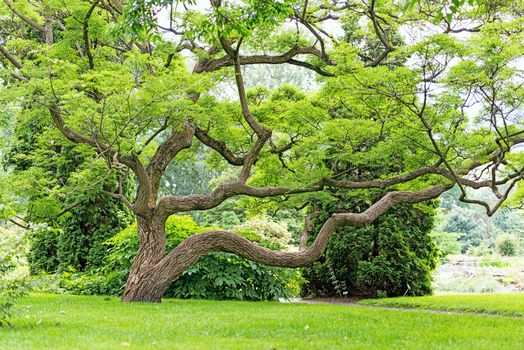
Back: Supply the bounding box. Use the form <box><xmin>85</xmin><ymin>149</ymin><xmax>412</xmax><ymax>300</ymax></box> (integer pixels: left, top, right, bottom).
<box><xmin>122</xmin><ymin>217</ymin><xmax>169</xmax><ymax>302</ymax></box>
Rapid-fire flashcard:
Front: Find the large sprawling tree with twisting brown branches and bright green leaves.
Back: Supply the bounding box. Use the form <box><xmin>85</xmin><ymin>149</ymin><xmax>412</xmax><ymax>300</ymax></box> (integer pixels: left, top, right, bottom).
<box><xmin>0</xmin><ymin>0</ymin><xmax>524</xmax><ymax>301</ymax></box>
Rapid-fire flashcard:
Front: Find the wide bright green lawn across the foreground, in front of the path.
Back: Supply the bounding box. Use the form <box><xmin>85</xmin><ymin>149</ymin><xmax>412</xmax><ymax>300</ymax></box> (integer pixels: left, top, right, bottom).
<box><xmin>0</xmin><ymin>295</ymin><xmax>524</xmax><ymax>350</ymax></box>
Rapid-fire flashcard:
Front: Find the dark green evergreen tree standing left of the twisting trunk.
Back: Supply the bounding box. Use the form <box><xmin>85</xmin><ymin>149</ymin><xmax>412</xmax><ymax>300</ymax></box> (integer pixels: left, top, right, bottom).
<box><xmin>2</xmin><ymin>106</ymin><xmax>130</xmax><ymax>273</ymax></box>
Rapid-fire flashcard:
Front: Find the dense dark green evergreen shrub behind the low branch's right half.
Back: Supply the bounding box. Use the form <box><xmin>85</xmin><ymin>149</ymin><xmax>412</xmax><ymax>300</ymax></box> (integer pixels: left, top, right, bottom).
<box><xmin>303</xmin><ymin>204</ymin><xmax>438</xmax><ymax>296</ymax></box>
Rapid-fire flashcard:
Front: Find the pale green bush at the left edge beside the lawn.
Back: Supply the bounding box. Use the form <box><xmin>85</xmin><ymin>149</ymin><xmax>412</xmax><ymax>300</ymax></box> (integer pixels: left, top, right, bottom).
<box><xmin>0</xmin><ymin>227</ymin><xmax>28</xmax><ymax>326</ymax></box>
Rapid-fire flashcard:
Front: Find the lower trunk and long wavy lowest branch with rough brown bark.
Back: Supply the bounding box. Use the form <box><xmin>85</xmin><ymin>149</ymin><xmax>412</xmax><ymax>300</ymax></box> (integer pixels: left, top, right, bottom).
<box><xmin>122</xmin><ymin>186</ymin><xmax>450</xmax><ymax>302</ymax></box>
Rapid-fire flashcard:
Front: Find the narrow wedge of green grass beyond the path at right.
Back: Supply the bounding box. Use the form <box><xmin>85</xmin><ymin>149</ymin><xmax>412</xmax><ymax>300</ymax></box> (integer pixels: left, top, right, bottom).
<box><xmin>359</xmin><ymin>293</ymin><xmax>524</xmax><ymax>317</ymax></box>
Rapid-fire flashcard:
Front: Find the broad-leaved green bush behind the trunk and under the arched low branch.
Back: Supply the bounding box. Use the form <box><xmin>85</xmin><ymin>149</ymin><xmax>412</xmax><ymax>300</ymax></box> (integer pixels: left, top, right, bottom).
<box><xmin>51</xmin><ymin>216</ymin><xmax>299</xmax><ymax>300</ymax></box>
